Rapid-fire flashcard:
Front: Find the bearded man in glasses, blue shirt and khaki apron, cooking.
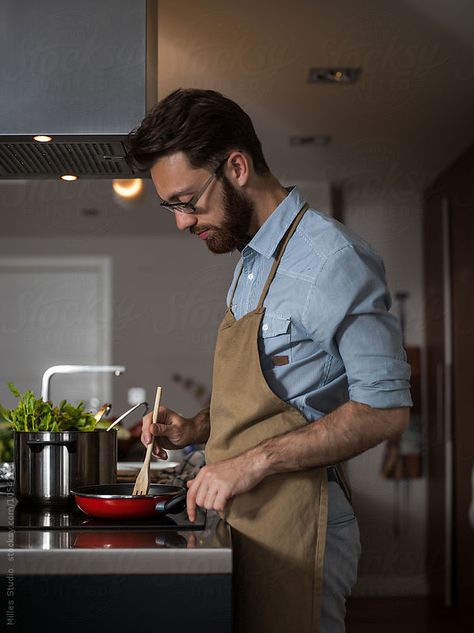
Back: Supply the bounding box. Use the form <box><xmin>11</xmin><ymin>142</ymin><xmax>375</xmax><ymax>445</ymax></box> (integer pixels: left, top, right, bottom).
<box><xmin>130</xmin><ymin>90</ymin><xmax>412</xmax><ymax>633</ymax></box>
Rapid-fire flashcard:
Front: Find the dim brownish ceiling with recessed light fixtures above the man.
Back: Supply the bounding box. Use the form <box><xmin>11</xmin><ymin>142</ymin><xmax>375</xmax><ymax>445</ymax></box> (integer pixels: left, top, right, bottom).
<box><xmin>0</xmin><ymin>0</ymin><xmax>474</xmax><ymax>235</ymax></box>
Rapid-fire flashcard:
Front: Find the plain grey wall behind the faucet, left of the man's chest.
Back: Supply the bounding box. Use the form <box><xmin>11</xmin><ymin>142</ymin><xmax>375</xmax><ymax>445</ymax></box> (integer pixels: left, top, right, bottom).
<box><xmin>0</xmin><ymin>234</ymin><xmax>236</xmax><ymax>415</ymax></box>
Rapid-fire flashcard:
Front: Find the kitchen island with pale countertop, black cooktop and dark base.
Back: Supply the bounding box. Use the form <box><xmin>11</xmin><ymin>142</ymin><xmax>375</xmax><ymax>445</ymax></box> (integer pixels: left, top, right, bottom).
<box><xmin>0</xmin><ymin>487</ymin><xmax>232</xmax><ymax>633</ymax></box>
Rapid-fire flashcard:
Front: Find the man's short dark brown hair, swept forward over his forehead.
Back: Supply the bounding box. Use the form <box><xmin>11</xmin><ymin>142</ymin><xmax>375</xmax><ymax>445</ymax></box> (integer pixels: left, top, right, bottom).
<box><xmin>128</xmin><ymin>88</ymin><xmax>270</xmax><ymax>175</ymax></box>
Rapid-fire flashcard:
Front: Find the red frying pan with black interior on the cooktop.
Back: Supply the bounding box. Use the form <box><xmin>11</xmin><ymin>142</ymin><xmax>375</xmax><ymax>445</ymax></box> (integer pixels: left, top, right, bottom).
<box><xmin>71</xmin><ymin>483</ymin><xmax>186</xmax><ymax>519</ymax></box>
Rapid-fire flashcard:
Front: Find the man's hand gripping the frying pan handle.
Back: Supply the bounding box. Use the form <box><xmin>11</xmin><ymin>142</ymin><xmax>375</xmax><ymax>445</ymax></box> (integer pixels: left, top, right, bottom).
<box><xmin>186</xmin><ymin>454</ymin><xmax>263</xmax><ymax>521</ymax></box>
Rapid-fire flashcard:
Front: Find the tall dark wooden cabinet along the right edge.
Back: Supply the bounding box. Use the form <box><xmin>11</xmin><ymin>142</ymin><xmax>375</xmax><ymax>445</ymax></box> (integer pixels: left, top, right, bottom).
<box><xmin>423</xmin><ymin>147</ymin><xmax>474</xmax><ymax>608</ymax></box>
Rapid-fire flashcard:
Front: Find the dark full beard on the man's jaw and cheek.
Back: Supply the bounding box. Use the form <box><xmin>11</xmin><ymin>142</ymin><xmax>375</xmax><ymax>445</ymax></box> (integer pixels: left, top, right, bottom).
<box><xmin>194</xmin><ymin>175</ymin><xmax>255</xmax><ymax>255</ymax></box>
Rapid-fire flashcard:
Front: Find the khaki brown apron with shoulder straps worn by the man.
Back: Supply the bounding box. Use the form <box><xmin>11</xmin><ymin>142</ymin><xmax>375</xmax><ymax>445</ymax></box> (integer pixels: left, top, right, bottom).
<box><xmin>206</xmin><ymin>204</ymin><xmax>347</xmax><ymax>633</ymax></box>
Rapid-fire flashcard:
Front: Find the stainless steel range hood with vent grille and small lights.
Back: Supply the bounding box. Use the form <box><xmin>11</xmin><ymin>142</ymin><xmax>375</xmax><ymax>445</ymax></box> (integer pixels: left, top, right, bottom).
<box><xmin>0</xmin><ymin>0</ymin><xmax>158</xmax><ymax>180</ymax></box>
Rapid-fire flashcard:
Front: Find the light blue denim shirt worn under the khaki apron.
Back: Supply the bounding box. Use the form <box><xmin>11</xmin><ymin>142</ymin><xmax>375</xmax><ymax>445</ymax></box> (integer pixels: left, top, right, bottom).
<box><xmin>227</xmin><ymin>187</ymin><xmax>412</xmax><ymax>421</ymax></box>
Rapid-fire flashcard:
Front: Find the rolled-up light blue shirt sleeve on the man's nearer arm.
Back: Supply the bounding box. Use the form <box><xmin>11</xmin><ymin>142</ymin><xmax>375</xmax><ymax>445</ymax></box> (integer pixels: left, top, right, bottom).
<box><xmin>303</xmin><ymin>244</ymin><xmax>412</xmax><ymax>408</ymax></box>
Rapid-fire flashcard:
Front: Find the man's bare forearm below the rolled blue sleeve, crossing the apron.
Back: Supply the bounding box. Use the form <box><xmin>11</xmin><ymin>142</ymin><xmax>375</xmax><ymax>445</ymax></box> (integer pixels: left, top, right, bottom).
<box><xmin>248</xmin><ymin>401</ymin><xmax>409</xmax><ymax>477</ymax></box>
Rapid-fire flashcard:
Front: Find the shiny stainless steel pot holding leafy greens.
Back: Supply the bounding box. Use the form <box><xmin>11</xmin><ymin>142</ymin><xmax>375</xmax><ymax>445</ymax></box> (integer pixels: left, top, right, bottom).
<box><xmin>14</xmin><ymin>429</ymin><xmax>117</xmax><ymax>505</ymax></box>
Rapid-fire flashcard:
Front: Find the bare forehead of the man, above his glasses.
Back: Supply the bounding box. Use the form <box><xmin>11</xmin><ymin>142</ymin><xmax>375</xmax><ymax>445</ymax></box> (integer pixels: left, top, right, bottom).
<box><xmin>150</xmin><ymin>152</ymin><xmax>207</xmax><ymax>200</ymax></box>
